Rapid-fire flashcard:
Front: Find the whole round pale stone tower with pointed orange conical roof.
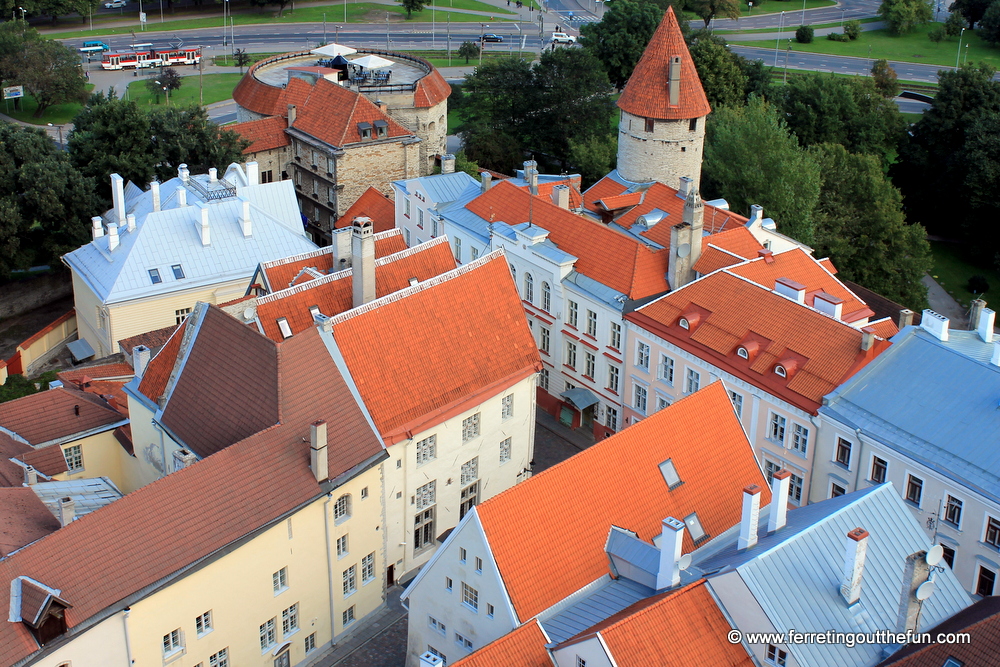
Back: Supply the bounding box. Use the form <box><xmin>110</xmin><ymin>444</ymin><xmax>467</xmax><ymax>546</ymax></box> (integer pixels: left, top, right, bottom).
<box><xmin>618</xmin><ymin>8</ymin><xmax>711</xmax><ymax>189</ymax></box>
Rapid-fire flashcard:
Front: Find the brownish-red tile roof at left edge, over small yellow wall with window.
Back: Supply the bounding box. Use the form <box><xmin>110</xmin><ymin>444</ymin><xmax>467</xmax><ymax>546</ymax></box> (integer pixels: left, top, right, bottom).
<box><xmin>0</xmin><ymin>387</ymin><xmax>122</xmax><ymax>446</ymax></box>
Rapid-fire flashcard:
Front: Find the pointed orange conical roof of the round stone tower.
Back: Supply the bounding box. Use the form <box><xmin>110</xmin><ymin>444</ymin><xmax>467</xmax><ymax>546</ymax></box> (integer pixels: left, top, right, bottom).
<box><xmin>618</xmin><ymin>7</ymin><xmax>712</xmax><ymax>120</ymax></box>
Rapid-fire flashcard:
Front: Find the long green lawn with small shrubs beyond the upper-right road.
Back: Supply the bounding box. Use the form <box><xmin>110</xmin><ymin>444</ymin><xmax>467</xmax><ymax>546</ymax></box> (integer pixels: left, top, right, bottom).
<box><xmin>740</xmin><ymin>23</ymin><xmax>1000</xmax><ymax>67</ymax></box>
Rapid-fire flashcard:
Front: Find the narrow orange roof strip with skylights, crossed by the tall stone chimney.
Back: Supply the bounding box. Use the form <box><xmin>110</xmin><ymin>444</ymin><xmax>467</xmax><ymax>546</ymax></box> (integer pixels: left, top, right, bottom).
<box><xmin>257</xmin><ymin>236</ymin><xmax>455</xmax><ymax>341</ymax></box>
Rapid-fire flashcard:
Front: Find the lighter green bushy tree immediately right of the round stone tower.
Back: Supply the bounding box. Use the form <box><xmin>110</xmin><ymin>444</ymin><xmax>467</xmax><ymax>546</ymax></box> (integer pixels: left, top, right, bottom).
<box><xmin>702</xmin><ymin>97</ymin><xmax>820</xmax><ymax>244</ymax></box>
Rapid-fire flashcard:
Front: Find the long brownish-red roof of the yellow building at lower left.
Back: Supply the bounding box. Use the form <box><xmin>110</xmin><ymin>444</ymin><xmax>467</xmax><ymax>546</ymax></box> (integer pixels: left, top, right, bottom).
<box><xmin>0</xmin><ymin>332</ymin><xmax>384</xmax><ymax>665</ymax></box>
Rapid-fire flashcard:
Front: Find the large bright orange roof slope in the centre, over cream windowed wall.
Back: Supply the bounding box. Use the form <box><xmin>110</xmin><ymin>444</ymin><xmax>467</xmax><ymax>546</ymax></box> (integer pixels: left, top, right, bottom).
<box><xmin>331</xmin><ymin>253</ymin><xmax>541</xmax><ymax>442</ymax></box>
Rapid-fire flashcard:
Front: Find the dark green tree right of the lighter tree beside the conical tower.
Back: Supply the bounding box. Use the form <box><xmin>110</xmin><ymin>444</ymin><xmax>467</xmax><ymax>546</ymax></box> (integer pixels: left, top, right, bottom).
<box><xmin>810</xmin><ymin>144</ymin><xmax>933</xmax><ymax>310</ymax></box>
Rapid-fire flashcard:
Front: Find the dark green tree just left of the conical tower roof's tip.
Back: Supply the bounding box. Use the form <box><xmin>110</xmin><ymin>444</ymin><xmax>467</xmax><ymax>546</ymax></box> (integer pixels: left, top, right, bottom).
<box><xmin>580</xmin><ymin>0</ymin><xmax>664</xmax><ymax>90</ymax></box>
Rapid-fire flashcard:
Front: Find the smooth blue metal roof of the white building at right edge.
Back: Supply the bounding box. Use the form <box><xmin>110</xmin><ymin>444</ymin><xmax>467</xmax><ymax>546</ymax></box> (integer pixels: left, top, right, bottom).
<box><xmin>820</xmin><ymin>327</ymin><xmax>1000</xmax><ymax>502</ymax></box>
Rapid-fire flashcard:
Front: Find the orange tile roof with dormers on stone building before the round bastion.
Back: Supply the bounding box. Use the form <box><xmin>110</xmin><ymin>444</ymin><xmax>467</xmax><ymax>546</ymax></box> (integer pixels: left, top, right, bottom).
<box><xmin>289</xmin><ymin>79</ymin><xmax>413</xmax><ymax>147</ymax></box>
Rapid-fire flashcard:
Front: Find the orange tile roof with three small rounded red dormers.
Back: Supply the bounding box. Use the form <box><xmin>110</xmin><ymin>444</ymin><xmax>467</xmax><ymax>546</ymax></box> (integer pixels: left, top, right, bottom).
<box><xmin>625</xmin><ymin>272</ymin><xmax>889</xmax><ymax>412</ymax></box>
